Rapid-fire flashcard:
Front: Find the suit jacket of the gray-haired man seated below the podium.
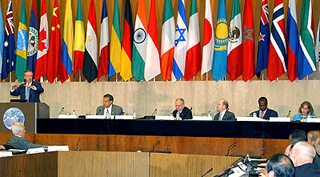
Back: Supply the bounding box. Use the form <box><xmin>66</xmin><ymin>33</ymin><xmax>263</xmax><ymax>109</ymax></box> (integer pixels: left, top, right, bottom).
<box><xmin>7</xmin><ymin>135</ymin><xmax>47</xmax><ymax>150</ymax></box>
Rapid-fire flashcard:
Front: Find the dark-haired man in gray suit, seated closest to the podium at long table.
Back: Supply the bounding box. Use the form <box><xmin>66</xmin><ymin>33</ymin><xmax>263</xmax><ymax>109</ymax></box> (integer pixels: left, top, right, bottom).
<box><xmin>96</xmin><ymin>94</ymin><xmax>123</xmax><ymax>116</ymax></box>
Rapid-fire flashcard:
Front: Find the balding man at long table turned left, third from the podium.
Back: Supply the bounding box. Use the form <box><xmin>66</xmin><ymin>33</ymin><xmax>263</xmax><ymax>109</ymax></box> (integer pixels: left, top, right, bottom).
<box><xmin>213</xmin><ymin>99</ymin><xmax>235</xmax><ymax>120</ymax></box>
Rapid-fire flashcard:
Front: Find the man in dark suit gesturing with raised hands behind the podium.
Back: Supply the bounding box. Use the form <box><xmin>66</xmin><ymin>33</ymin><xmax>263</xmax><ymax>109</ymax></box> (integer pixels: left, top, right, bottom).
<box><xmin>10</xmin><ymin>70</ymin><xmax>44</xmax><ymax>103</ymax></box>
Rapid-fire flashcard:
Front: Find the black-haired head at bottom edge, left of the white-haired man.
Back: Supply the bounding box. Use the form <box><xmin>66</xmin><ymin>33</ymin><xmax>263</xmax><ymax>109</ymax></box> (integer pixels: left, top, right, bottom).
<box><xmin>267</xmin><ymin>154</ymin><xmax>294</xmax><ymax>177</ymax></box>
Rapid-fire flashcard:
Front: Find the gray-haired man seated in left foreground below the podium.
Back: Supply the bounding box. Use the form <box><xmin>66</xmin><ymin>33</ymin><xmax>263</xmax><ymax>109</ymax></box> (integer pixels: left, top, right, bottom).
<box><xmin>7</xmin><ymin>122</ymin><xmax>47</xmax><ymax>150</ymax></box>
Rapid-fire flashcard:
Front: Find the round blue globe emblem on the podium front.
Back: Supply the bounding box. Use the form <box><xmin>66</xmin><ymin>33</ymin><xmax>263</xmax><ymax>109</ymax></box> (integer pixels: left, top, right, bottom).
<box><xmin>3</xmin><ymin>107</ymin><xmax>25</xmax><ymax>130</ymax></box>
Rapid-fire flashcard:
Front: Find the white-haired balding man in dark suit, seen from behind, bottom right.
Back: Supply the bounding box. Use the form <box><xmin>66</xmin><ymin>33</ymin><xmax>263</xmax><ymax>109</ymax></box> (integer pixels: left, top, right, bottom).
<box><xmin>289</xmin><ymin>142</ymin><xmax>320</xmax><ymax>177</ymax></box>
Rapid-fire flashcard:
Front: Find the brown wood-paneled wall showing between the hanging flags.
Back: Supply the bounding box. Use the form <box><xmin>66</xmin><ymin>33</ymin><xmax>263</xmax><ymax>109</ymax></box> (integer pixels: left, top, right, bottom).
<box><xmin>0</xmin><ymin>0</ymin><xmax>320</xmax><ymax>81</ymax></box>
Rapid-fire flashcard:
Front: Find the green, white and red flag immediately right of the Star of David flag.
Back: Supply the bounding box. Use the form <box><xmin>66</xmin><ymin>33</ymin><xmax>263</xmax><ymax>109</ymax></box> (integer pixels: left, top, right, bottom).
<box><xmin>184</xmin><ymin>0</ymin><xmax>201</xmax><ymax>81</ymax></box>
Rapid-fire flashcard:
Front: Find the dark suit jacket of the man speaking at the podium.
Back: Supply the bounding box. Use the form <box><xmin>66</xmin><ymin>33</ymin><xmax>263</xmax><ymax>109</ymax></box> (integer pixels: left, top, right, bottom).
<box><xmin>10</xmin><ymin>82</ymin><xmax>44</xmax><ymax>103</ymax></box>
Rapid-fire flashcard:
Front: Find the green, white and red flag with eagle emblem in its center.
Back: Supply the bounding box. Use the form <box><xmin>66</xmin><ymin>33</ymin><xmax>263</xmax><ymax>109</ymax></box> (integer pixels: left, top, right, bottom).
<box><xmin>227</xmin><ymin>0</ymin><xmax>242</xmax><ymax>81</ymax></box>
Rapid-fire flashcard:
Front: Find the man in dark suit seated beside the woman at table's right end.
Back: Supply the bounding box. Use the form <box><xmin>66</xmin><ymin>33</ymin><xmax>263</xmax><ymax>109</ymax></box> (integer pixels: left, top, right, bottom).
<box><xmin>250</xmin><ymin>97</ymin><xmax>278</xmax><ymax>120</ymax></box>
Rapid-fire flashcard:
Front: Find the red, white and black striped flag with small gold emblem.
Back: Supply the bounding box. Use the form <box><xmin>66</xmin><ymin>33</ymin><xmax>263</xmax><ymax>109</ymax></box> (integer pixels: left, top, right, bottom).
<box><xmin>83</xmin><ymin>0</ymin><xmax>98</xmax><ymax>83</ymax></box>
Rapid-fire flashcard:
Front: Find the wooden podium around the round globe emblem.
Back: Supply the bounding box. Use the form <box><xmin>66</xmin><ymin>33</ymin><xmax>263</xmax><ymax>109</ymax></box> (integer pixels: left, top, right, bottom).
<box><xmin>0</xmin><ymin>103</ymin><xmax>50</xmax><ymax>133</ymax></box>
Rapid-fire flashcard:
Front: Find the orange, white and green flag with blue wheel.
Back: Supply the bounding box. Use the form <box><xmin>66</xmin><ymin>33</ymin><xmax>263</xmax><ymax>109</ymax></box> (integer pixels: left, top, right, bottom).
<box><xmin>132</xmin><ymin>0</ymin><xmax>148</xmax><ymax>82</ymax></box>
